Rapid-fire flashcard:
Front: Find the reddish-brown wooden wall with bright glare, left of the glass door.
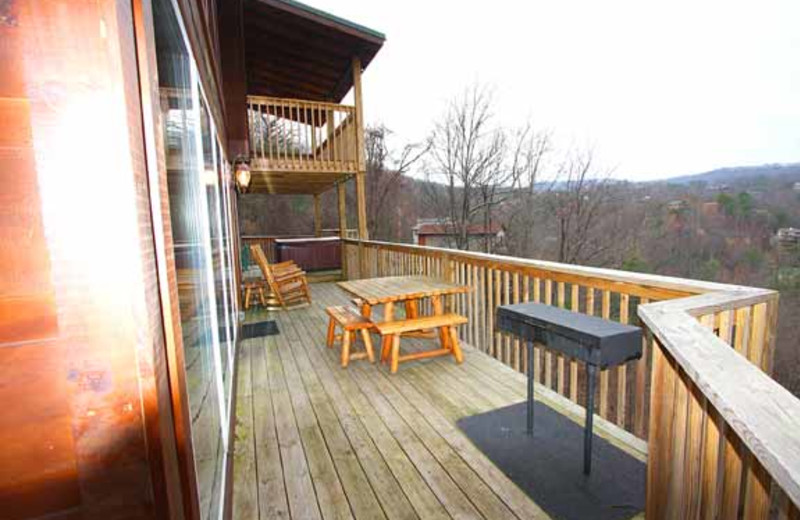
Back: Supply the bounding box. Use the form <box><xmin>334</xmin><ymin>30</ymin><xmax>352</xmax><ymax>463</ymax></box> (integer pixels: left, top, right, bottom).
<box><xmin>0</xmin><ymin>0</ymin><xmax>183</xmax><ymax>519</ymax></box>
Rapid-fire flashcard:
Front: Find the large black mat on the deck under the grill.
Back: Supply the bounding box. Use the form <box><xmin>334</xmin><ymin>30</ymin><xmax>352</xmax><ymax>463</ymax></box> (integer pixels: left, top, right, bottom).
<box><xmin>458</xmin><ymin>401</ymin><xmax>646</xmax><ymax>520</ymax></box>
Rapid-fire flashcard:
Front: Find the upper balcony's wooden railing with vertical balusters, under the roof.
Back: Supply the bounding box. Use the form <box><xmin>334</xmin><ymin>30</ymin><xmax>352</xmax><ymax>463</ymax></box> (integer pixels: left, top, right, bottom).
<box><xmin>247</xmin><ymin>96</ymin><xmax>359</xmax><ymax>173</ymax></box>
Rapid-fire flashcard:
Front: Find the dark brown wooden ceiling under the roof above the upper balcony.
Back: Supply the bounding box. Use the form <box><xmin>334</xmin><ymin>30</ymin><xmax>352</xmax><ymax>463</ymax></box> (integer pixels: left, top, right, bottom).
<box><xmin>244</xmin><ymin>0</ymin><xmax>385</xmax><ymax>102</ymax></box>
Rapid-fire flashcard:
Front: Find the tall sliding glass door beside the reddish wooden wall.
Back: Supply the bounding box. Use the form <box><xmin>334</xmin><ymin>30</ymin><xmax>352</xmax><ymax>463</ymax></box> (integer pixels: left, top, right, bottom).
<box><xmin>154</xmin><ymin>0</ymin><xmax>237</xmax><ymax>519</ymax></box>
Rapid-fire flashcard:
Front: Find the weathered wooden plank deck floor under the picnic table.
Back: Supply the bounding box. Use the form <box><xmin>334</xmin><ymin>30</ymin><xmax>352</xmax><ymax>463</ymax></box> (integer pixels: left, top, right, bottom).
<box><xmin>233</xmin><ymin>283</ymin><xmax>646</xmax><ymax>520</ymax></box>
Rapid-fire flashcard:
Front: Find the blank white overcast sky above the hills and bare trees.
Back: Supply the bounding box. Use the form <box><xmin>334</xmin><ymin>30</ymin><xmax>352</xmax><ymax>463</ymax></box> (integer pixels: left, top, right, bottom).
<box><xmin>306</xmin><ymin>0</ymin><xmax>800</xmax><ymax>180</ymax></box>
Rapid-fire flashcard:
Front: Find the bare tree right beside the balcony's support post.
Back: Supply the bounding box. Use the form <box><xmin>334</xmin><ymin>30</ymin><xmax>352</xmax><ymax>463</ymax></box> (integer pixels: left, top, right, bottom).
<box><xmin>364</xmin><ymin>125</ymin><xmax>429</xmax><ymax>240</ymax></box>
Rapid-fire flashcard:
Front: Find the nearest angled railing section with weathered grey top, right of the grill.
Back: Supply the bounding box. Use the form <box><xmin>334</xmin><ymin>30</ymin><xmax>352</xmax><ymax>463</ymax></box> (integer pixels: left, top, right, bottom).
<box><xmin>639</xmin><ymin>289</ymin><xmax>800</xmax><ymax>519</ymax></box>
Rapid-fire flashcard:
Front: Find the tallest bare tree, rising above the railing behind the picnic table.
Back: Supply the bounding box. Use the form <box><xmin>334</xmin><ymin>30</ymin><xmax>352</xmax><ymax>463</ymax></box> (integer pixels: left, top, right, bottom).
<box><xmin>426</xmin><ymin>85</ymin><xmax>519</xmax><ymax>251</ymax></box>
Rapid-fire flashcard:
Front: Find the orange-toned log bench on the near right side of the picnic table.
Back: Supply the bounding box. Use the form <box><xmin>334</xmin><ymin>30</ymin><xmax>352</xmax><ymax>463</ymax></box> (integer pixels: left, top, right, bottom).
<box><xmin>375</xmin><ymin>314</ymin><xmax>468</xmax><ymax>374</ymax></box>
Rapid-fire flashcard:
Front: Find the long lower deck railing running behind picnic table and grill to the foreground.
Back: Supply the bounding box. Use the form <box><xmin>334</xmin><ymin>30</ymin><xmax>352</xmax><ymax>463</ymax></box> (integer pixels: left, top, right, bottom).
<box><xmin>343</xmin><ymin>240</ymin><xmax>800</xmax><ymax>518</ymax></box>
